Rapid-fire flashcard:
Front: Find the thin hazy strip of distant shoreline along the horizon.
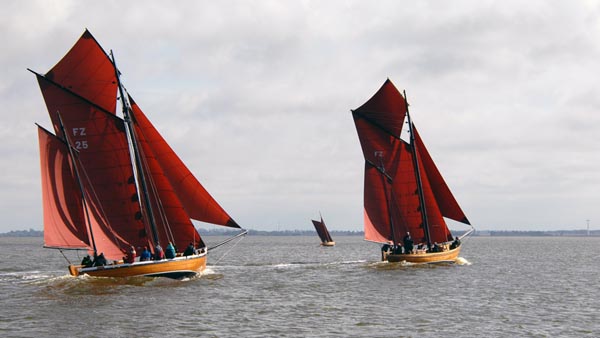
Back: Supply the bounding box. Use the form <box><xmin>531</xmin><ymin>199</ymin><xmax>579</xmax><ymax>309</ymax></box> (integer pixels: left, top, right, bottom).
<box><xmin>0</xmin><ymin>229</ymin><xmax>600</xmax><ymax>238</ymax></box>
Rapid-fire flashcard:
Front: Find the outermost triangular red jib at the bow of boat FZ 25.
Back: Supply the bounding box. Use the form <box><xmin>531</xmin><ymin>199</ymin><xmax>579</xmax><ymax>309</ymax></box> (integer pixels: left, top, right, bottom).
<box><xmin>130</xmin><ymin>98</ymin><xmax>240</xmax><ymax>228</ymax></box>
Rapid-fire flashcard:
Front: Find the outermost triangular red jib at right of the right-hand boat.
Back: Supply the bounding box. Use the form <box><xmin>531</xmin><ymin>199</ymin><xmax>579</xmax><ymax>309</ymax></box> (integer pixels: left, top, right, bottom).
<box><xmin>413</xmin><ymin>127</ymin><xmax>470</xmax><ymax>224</ymax></box>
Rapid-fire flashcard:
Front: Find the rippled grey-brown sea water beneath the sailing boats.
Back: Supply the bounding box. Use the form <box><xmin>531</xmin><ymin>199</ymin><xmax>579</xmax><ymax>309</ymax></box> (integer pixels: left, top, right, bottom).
<box><xmin>0</xmin><ymin>234</ymin><xmax>600</xmax><ymax>337</ymax></box>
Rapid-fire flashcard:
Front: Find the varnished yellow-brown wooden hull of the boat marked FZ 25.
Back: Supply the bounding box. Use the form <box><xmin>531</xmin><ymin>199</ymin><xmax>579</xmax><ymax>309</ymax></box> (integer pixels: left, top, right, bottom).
<box><xmin>69</xmin><ymin>252</ymin><xmax>206</xmax><ymax>278</ymax></box>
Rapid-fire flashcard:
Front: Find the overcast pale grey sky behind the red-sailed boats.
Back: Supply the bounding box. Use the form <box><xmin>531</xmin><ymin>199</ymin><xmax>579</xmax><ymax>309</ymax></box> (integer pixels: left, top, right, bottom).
<box><xmin>0</xmin><ymin>0</ymin><xmax>600</xmax><ymax>232</ymax></box>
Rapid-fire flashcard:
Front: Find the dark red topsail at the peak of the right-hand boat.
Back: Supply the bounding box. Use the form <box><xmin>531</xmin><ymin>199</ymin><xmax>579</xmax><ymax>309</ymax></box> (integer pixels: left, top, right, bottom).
<box><xmin>354</xmin><ymin>79</ymin><xmax>406</xmax><ymax>137</ymax></box>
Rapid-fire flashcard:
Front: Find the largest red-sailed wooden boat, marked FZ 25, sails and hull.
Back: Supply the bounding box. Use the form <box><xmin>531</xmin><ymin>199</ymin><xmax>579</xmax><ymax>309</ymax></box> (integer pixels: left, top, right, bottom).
<box><xmin>30</xmin><ymin>30</ymin><xmax>245</xmax><ymax>278</ymax></box>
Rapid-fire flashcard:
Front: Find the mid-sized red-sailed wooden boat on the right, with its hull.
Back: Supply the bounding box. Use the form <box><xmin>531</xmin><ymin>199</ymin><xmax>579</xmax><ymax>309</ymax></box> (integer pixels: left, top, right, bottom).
<box><xmin>352</xmin><ymin>79</ymin><xmax>473</xmax><ymax>263</ymax></box>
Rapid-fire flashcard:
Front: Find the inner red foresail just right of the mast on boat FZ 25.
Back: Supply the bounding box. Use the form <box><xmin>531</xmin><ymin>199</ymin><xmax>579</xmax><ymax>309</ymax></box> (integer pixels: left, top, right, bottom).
<box><xmin>136</xmin><ymin>117</ymin><xmax>203</xmax><ymax>249</ymax></box>
